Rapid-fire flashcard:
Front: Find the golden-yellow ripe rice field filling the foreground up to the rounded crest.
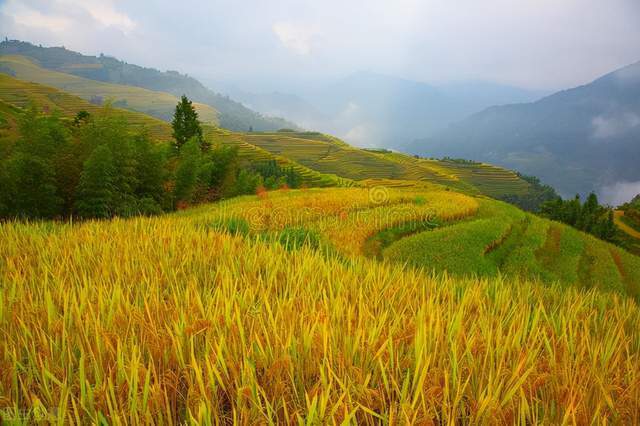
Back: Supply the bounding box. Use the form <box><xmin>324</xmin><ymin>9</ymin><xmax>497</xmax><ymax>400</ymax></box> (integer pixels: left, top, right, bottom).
<box><xmin>0</xmin><ymin>187</ymin><xmax>640</xmax><ymax>424</ymax></box>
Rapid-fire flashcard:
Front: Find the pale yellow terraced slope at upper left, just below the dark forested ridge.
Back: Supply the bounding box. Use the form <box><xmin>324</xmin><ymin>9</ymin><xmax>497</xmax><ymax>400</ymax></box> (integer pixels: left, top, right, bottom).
<box><xmin>0</xmin><ymin>55</ymin><xmax>218</xmax><ymax>124</ymax></box>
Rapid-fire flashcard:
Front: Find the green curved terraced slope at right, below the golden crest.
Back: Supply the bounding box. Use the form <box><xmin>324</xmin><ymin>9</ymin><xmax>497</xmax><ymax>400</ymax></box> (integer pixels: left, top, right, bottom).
<box><xmin>383</xmin><ymin>200</ymin><xmax>640</xmax><ymax>300</ymax></box>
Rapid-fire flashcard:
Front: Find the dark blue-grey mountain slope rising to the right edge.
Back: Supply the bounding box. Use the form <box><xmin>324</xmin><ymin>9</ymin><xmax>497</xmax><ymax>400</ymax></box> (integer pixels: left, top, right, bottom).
<box><xmin>405</xmin><ymin>62</ymin><xmax>640</xmax><ymax>203</ymax></box>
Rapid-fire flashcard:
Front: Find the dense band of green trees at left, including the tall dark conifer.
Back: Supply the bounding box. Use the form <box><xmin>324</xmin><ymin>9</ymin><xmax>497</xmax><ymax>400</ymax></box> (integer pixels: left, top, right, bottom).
<box><xmin>0</xmin><ymin>96</ymin><xmax>301</xmax><ymax>219</ymax></box>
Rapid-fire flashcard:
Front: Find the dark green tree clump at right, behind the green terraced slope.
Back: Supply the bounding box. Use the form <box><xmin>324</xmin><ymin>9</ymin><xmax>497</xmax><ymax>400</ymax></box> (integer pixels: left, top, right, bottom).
<box><xmin>540</xmin><ymin>193</ymin><xmax>616</xmax><ymax>241</ymax></box>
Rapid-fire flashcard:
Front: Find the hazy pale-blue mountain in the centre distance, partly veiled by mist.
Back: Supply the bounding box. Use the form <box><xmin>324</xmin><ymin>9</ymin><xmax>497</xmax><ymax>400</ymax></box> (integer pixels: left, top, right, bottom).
<box><xmin>226</xmin><ymin>72</ymin><xmax>541</xmax><ymax>148</ymax></box>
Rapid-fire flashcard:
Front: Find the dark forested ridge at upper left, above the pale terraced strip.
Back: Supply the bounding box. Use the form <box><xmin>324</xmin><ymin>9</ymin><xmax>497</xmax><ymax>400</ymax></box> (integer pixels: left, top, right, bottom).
<box><xmin>0</xmin><ymin>40</ymin><xmax>297</xmax><ymax>131</ymax></box>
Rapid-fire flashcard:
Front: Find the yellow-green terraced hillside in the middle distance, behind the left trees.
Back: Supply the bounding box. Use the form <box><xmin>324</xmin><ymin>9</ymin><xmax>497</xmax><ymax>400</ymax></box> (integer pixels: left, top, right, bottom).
<box><xmin>0</xmin><ymin>72</ymin><xmax>552</xmax><ymax>206</ymax></box>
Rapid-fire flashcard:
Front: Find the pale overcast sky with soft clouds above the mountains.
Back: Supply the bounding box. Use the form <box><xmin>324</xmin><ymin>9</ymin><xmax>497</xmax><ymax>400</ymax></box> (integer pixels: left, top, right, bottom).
<box><xmin>0</xmin><ymin>0</ymin><xmax>640</xmax><ymax>90</ymax></box>
